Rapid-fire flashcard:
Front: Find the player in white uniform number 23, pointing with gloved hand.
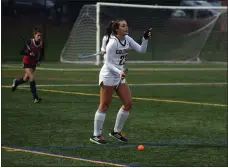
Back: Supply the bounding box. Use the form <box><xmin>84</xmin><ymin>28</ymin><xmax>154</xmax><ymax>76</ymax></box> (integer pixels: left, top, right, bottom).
<box><xmin>90</xmin><ymin>20</ymin><xmax>151</xmax><ymax>144</ymax></box>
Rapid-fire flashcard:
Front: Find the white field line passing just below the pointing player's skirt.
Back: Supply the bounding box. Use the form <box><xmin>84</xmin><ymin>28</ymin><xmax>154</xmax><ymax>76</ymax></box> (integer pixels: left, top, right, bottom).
<box><xmin>2</xmin><ymin>82</ymin><xmax>227</xmax><ymax>88</ymax></box>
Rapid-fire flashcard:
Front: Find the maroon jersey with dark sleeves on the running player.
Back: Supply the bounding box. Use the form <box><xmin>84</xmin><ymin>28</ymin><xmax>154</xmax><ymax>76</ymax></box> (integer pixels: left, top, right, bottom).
<box><xmin>21</xmin><ymin>39</ymin><xmax>44</xmax><ymax>66</ymax></box>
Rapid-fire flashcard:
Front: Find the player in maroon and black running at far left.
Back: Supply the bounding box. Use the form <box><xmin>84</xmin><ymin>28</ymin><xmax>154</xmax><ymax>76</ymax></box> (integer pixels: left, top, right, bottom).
<box><xmin>12</xmin><ymin>28</ymin><xmax>44</xmax><ymax>103</ymax></box>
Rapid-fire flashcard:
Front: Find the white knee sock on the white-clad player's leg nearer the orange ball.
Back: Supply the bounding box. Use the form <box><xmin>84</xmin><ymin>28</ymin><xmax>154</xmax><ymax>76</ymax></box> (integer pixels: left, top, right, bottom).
<box><xmin>114</xmin><ymin>108</ymin><xmax>129</xmax><ymax>132</ymax></box>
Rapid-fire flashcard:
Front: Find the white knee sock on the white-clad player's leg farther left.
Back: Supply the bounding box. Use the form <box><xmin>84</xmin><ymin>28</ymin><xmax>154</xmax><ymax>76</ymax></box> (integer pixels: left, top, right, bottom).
<box><xmin>93</xmin><ymin>110</ymin><xmax>106</xmax><ymax>136</ymax></box>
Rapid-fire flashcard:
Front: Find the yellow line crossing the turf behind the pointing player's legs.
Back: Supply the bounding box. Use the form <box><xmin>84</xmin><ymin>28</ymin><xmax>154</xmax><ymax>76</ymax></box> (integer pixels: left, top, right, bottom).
<box><xmin>2</xmin><ymin>85</ymin><xmax>228</xmax><ymax>107</ymax></box>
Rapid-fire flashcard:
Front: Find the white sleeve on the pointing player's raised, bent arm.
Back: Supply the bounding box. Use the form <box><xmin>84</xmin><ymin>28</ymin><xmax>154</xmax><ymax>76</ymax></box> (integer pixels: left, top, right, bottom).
<box><xmin>126</xmin><ymin>36</ymin><xmax>148</xmax><ymax>53</ymax></box>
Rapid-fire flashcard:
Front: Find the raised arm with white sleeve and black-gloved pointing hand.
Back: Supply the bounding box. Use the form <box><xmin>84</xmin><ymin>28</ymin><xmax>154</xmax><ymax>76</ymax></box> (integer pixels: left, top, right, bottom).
<box><xmin>126</xmin><ymin>29</ymin><xmax>152</xmax><ymax>53</ymax></box>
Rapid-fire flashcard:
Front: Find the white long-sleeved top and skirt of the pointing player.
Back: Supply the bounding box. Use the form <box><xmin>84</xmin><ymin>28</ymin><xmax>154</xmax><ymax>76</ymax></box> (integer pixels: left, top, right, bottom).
<box><xmin>99</xmin><ymin>35</ymin><xmax>148</xmax><ymax>86</ymax></box>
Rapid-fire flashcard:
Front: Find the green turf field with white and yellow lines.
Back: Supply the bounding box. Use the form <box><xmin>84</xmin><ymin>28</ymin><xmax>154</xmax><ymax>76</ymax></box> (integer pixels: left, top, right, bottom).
<box><xmin>1</xmin><ymin>63</ymin><xmax>228</xmax><ymax>167</ymax></box>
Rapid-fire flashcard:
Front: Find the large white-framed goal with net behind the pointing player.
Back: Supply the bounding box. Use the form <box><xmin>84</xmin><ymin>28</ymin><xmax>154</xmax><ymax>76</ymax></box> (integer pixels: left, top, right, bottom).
<box><xmin>60</xmin><ymin>3</ymin><xmax>227</xmax><ymax>65</ymax></box>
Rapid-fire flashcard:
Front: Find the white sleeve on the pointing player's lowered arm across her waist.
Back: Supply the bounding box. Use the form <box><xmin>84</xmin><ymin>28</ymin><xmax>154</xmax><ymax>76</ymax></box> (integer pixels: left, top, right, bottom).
<box><xmin>105</xmin><ymin>39</ymin><xmax>121</xmax><ymax>74</ymax></box>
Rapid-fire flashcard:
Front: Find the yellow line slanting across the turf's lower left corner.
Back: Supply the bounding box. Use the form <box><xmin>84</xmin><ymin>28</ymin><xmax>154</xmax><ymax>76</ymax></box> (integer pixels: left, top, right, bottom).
<box><xmin>2</xmin><ymin>146</ymin><xmax>126</xmax><ymax>167</ymax></box>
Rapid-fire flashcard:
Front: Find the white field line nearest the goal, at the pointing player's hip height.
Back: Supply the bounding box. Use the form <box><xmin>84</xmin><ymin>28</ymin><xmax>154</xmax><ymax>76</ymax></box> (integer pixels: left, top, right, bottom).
<box><xmin>2</xmin><ymin>65</ymin><xmax>227</xmax><ymax>71</ymax></box>
